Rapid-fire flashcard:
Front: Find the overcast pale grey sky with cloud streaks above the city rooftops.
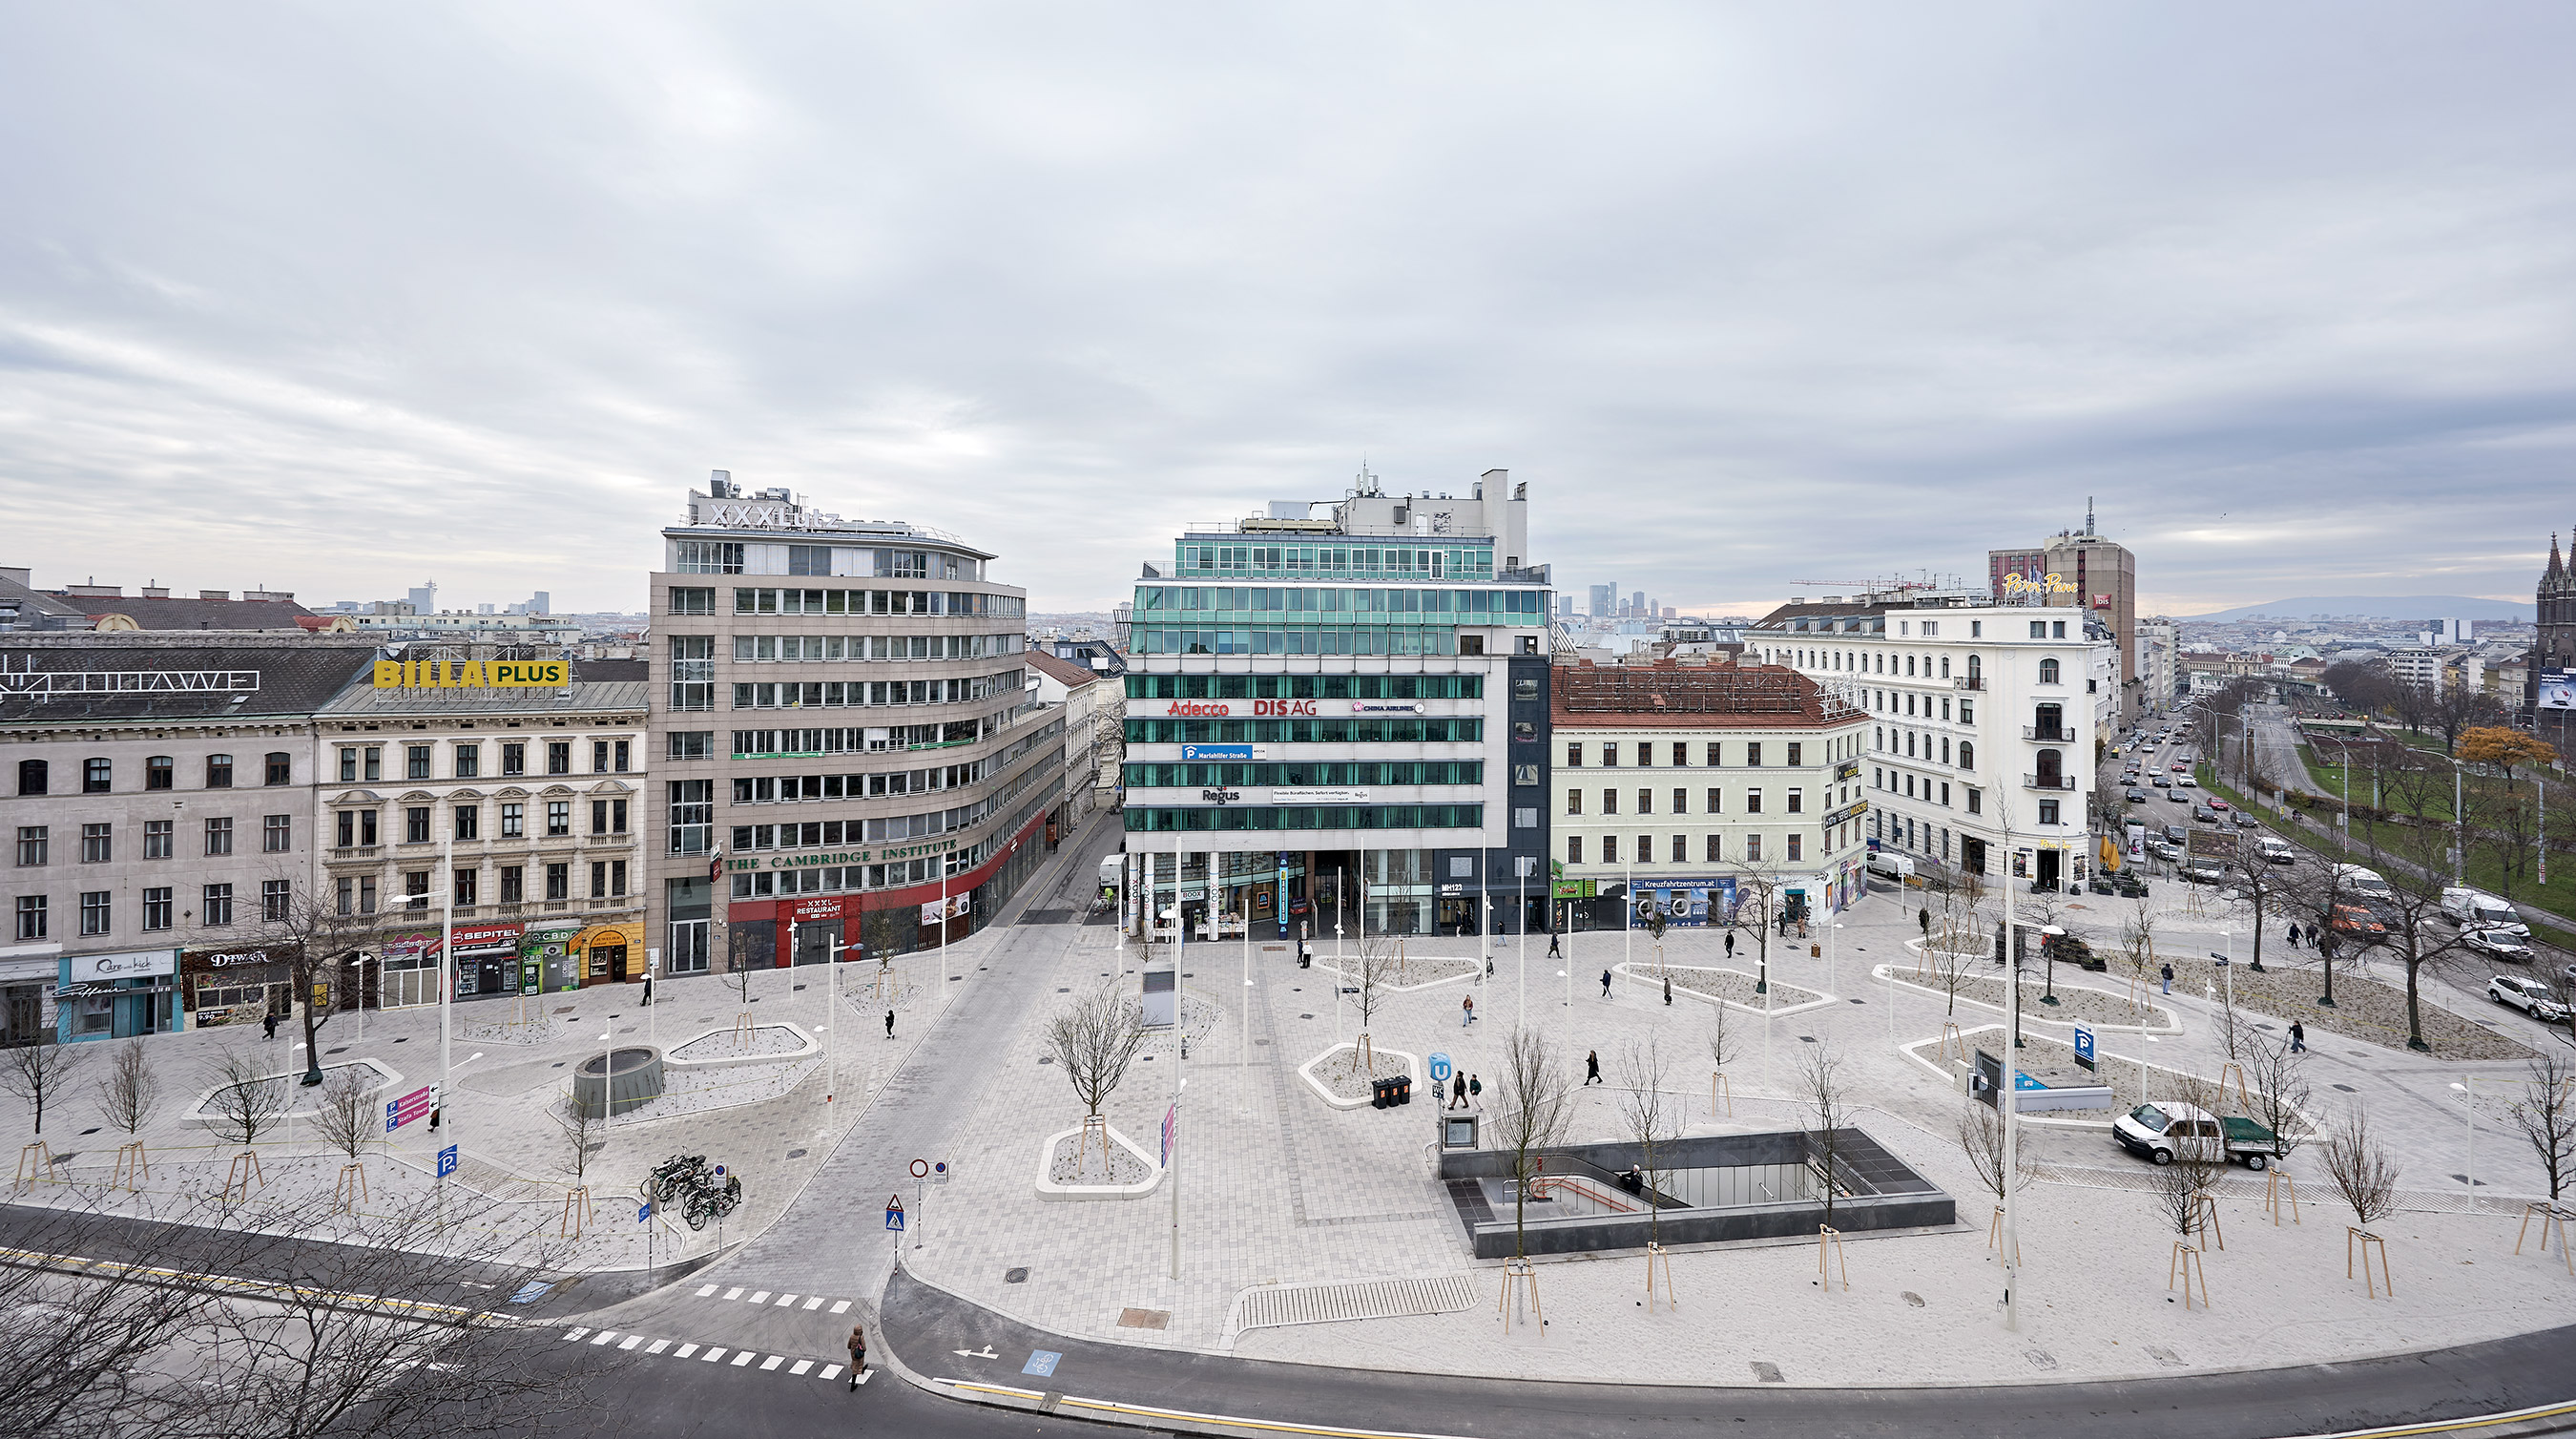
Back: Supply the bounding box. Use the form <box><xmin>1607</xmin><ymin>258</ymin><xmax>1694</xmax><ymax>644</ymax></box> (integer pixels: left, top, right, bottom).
<box><xmin>0</xmin><ymin>3</ymin><xmax>2576</xmax><ymax>613</ymax></box>
